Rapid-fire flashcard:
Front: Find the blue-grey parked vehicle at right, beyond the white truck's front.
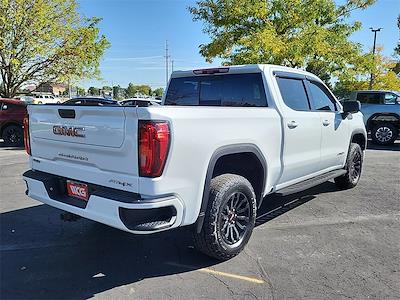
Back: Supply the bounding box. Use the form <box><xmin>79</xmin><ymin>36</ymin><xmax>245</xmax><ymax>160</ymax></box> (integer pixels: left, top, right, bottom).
<box><xmin>350</xmin><ymin>91</ymin><xmax>400</xmax><ymax>145</ymax></box>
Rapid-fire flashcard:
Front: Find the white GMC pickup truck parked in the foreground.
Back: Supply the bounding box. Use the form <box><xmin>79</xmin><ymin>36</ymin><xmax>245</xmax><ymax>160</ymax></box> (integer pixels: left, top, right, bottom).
<box><xmin>23</xmin><ymin>65</ymin><xmax>367</xmax><ymax>260</ymax></box>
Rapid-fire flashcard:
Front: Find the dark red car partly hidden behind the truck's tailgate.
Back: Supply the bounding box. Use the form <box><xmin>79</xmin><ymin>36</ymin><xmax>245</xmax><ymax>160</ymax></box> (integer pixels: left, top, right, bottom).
<box><xmin>0</xmin><ymin>98</ymin><xmax>27</xmax><ymax>146</ymax></box>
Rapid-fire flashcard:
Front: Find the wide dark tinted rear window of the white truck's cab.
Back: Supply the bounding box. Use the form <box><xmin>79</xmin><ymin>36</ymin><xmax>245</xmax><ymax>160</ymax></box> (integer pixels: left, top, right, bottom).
<box><xmin>165</xmin><ymin>73</ymin><xmax>267</xmax><ymax>107</ymax></box>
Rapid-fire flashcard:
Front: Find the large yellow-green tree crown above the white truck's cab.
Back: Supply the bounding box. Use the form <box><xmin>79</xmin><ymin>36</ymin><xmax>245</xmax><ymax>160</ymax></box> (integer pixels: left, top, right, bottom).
<box><xmin>189</xmin><ymin>0</ymin><xmax>376</xmax><ymax>80</ymax></box>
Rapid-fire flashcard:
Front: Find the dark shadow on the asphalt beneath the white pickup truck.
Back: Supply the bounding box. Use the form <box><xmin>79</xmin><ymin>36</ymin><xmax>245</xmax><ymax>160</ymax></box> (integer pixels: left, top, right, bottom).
<box><xmin>0</xmin><ymin>182</ymin><xmax>336</xmax><ymax>299</ymax></box>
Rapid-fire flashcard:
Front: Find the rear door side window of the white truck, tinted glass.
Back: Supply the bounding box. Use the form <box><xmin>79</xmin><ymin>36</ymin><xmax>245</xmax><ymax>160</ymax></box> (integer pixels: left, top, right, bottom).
<box><xmin>277</xmin><ymin>77</ymin><xmax>311</xmax><ymax>111</ymax></box>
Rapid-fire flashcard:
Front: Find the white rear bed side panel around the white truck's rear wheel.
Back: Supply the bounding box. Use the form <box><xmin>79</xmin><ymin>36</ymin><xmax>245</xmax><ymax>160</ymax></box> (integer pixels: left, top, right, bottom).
<box><xmin>137</xmin><ymin>106</ymin><xmax>282</xmax><ymax>225</ymax></box>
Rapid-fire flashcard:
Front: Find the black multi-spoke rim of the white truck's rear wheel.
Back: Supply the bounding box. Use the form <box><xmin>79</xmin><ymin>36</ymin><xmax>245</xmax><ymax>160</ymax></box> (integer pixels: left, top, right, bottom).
<box><xmin>220</xmin><ymin>192</ymin><xmax>251</xmax><ymax>246</ymax></box>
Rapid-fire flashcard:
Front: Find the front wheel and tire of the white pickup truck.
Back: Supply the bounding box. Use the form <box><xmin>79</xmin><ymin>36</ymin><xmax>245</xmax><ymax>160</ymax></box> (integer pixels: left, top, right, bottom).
<box><xmin>335</xmin><ymin>143</ymin><xmax>363</xmax><ymax>190</ymax></box>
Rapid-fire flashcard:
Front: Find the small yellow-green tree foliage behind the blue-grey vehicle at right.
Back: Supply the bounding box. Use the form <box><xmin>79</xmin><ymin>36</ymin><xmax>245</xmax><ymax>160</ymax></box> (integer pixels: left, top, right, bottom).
<box><xmin>335</xmin><ymin>47</ymin><xmax>400</xmax><ymax>97</ymax></box>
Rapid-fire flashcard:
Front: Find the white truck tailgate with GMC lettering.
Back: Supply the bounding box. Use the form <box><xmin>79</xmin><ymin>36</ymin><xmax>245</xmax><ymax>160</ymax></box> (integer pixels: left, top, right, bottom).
<box><xmin>28</xmin><ymin>105</ymin><xmax>138</xmax><ymax>191</ymax></box>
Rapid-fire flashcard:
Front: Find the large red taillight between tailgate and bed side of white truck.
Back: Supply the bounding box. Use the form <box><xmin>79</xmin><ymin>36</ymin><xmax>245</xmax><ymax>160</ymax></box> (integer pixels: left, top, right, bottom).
<box><xmin>139</xmin><ymin>121</ymin><xmax>170</xmax><ymax>177</ymax></box>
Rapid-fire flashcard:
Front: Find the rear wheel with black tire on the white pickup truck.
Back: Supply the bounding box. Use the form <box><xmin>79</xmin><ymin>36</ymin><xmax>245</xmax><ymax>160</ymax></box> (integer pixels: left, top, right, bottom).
<box><xmin>194</xmin><ymin>174</ymin><xmax>256</xmax><ymax>260</ymax></box>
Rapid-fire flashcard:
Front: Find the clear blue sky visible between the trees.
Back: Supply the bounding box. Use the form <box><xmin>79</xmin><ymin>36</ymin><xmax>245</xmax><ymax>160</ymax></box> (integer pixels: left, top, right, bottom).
<box><xmin>78</xmin><ymin>0</ymin><xmax>400</xmax><ymax>88</ymax></box>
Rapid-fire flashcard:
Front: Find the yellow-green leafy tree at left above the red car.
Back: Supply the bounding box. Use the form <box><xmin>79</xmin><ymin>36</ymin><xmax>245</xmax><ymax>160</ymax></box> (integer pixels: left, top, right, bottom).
<box><xmin>0</xmin><ymin>0</ymin><xmax>109</xmax><ymax>97</ymax></box>
